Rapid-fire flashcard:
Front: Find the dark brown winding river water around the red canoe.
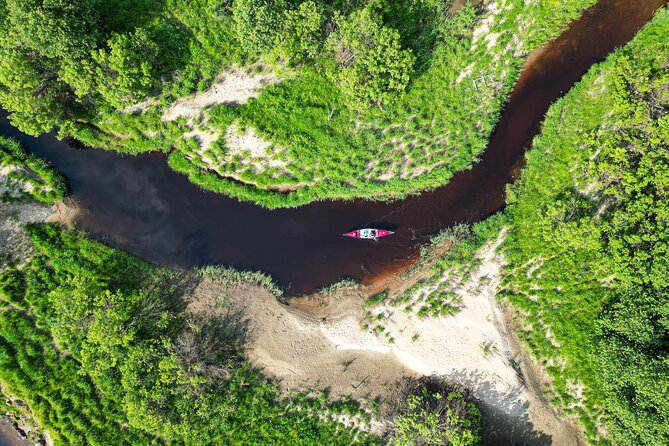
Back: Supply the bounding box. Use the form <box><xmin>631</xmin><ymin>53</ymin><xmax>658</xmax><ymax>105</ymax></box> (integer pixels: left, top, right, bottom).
<box><xmin>0</xmin><ymin>0</ymin><xmax>666</xmax><ymax>294</ymax></box>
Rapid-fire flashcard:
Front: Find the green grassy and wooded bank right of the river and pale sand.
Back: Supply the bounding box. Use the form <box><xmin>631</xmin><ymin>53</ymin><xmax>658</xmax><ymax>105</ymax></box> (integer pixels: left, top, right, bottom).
<box><xmin>504</xmin><ymin>9</ymin><xmax>669</xmax><ymax>445</ymax></box>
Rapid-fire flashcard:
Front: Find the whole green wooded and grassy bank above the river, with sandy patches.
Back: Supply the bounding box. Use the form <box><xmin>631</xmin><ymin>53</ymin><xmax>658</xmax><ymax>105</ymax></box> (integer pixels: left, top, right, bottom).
<box><xmin>0</xmin><ymin>0</ymin><xmax>594</xmax><ymax>207</ymax></box>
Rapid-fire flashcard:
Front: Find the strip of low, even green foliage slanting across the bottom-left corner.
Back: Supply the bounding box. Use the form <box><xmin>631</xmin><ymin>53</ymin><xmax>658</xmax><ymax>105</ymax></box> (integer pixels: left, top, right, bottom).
<box><xmin>0</xmin><ymin>309</ymin><xmax>151</xmax><ymax>445</ymax></box>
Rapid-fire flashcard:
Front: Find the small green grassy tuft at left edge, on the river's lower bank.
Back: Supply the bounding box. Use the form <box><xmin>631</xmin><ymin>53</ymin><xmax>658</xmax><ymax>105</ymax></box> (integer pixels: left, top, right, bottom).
<box><xmin>0</xmin><ymin>137</ymin><xmax>67</xmax><ymax>204</ymax></box>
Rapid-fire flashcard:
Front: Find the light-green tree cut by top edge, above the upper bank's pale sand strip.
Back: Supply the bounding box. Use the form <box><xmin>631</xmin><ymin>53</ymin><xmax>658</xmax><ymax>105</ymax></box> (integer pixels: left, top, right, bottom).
<box><xmin>232</xmin><ymin>0</ymin><xmax>286</xmax><ymax>55</ymax></box>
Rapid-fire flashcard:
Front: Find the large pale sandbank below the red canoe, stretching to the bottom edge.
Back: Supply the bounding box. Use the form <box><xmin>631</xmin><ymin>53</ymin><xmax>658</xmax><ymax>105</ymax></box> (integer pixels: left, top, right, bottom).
<box><xmin>187</xmin><ymin>235</ymin><xmax>579</xmax><ymax>445</ymax></box>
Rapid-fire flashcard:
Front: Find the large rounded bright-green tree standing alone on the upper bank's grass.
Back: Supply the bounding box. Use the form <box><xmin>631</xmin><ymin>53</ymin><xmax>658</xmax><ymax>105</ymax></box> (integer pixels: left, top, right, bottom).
<box><xmin>328</xmin><ymin>6</ymin><xmax>415</xmax><ymax>109</ymax></box>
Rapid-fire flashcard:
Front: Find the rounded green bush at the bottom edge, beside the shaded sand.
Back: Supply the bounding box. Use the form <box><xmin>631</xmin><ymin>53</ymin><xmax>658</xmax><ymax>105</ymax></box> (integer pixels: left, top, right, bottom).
<box><xmin>390</xmin><ymin>377</ymin><xmax>481</xmax><ymax>446</ymax></box>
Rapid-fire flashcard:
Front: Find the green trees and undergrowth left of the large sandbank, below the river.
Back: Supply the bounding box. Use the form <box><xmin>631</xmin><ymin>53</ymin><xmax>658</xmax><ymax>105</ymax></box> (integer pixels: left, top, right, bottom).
<box><xmin>0</xmin><ymin>225</ymin><xmax>375</xmax><ymax>445</ymax></box>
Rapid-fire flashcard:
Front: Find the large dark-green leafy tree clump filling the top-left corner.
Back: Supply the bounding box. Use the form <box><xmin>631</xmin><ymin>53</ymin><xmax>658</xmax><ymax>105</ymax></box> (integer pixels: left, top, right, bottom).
<box><xmin>0</xmin><ymin>0</ymin><xmax>98</xmax><ymax>135</ymax></box>
